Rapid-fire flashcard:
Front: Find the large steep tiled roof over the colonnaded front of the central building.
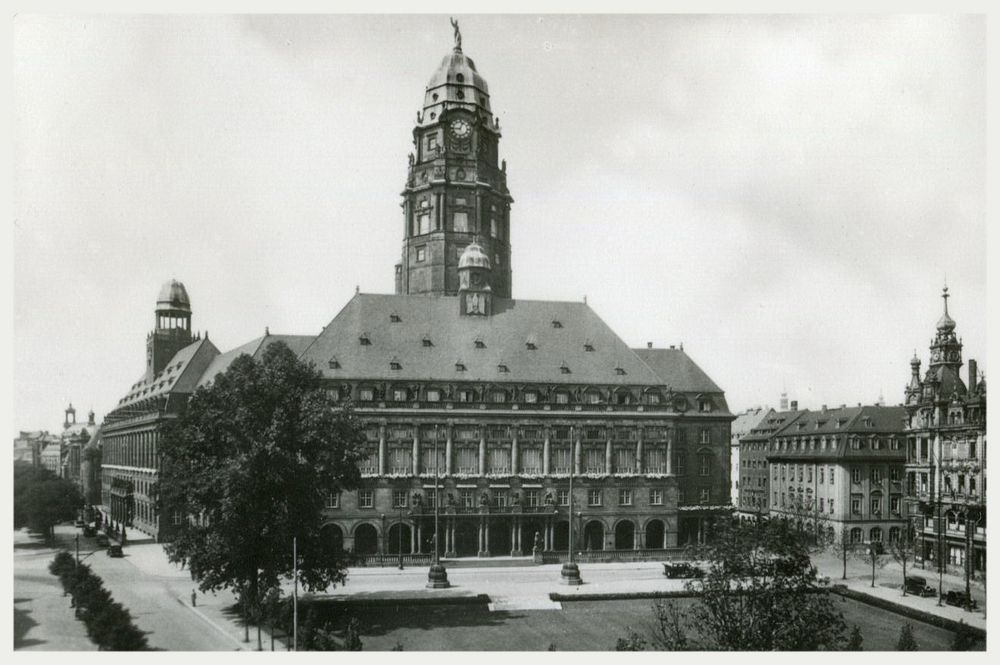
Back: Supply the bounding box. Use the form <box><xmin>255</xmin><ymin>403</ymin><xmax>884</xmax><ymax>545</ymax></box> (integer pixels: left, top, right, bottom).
<box><xmin>302</xmin><ymin>294</ymin><xmax>721</xmax><ymax>392</ymax></box>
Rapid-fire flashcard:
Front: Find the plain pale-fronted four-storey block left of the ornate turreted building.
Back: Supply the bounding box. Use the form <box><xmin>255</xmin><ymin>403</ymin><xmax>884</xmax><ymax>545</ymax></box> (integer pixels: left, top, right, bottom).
<box><xmin>767</xmin><ymin>406</ymin><xmax>907</xmax><ymax>545</ymax></box>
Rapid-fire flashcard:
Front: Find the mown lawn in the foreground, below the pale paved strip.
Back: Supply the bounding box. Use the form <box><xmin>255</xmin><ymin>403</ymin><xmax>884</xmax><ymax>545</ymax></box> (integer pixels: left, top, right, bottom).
<box><xmin>310</xmin><ymin>597</ymin><xmax>968</xmax><ymax>651</ymax></box>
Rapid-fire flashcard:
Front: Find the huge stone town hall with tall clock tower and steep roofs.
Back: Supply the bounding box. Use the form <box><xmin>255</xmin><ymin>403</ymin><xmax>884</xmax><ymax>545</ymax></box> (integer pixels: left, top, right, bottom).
<box><xmin>102</xmin><ymin>22</ymin><xmax>733</xmax><ymax>548</ymax></box>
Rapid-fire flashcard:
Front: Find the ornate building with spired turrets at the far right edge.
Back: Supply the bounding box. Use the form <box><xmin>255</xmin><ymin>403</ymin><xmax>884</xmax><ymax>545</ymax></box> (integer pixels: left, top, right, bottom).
<box><xmin>906</xmin><ymin>287</ymin><xmax>986</xmax><ymax>577</ymax></box>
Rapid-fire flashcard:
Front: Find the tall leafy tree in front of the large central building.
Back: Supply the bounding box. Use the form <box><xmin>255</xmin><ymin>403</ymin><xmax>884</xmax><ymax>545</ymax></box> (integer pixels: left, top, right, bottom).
<box><xmin>158</xmin><ymin>342</ymin><xmax>364</xmax><ymax>644</ymax></box>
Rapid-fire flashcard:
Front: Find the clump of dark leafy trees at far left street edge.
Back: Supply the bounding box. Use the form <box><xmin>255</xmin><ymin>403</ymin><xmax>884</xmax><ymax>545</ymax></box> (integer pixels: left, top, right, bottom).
<box><xmin>14</xmin><ymin>462</ymin><xmax>83</xmax><ymax>540</ymax></box>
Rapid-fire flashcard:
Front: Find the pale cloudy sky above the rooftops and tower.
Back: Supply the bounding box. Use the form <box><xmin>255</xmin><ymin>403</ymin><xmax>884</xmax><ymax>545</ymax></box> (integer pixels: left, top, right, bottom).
<box><xmin>12</xmin><ymin>14</ymin><xmax>989</xmax><ymax>430</ymax></box>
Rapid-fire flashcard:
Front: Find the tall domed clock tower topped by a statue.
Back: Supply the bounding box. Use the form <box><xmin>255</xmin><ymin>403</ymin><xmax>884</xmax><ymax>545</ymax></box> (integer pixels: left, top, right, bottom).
<box><xmin>396</xmin><ymin>21</ymin><xmax>513</xmax><ymax>298</ymax></box>
